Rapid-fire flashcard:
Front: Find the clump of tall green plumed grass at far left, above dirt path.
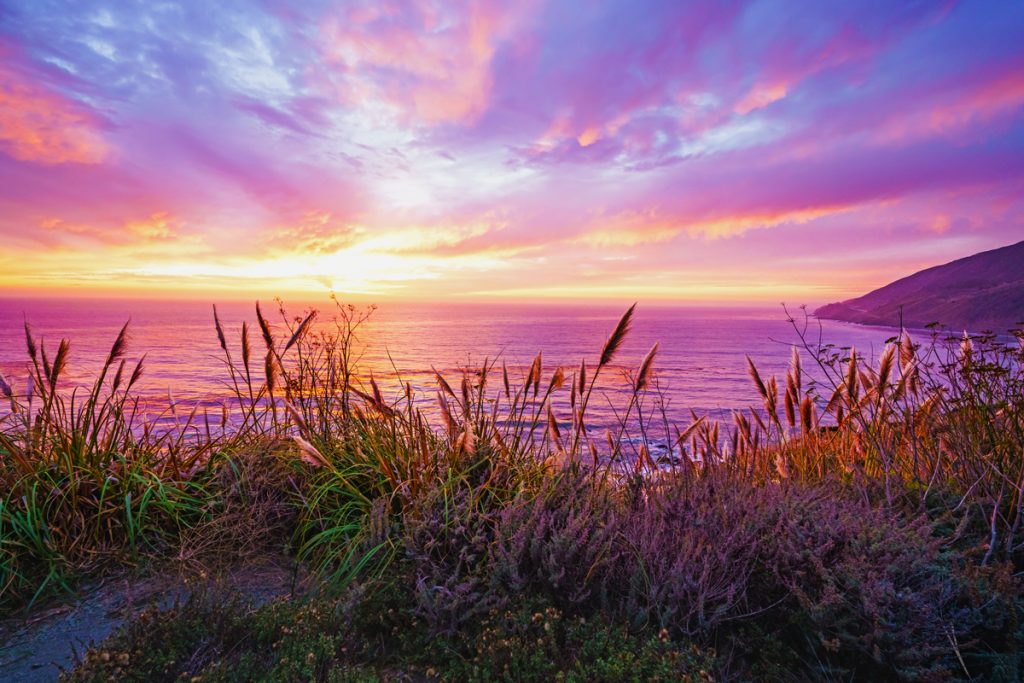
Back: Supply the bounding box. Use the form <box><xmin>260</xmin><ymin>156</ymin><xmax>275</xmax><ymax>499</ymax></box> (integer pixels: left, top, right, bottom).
<box><xmin>0</xmin><ymin>325</ymin><xmax>214</xmax><ymax>599</ymax></box>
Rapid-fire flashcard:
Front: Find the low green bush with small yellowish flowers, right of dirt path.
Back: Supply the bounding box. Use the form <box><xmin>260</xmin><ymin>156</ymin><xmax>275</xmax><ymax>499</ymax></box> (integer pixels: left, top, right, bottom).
<box><xmin>61</xmin><ymin>586</ymin><xmax>712</xmax><ymax>683</ymax></box>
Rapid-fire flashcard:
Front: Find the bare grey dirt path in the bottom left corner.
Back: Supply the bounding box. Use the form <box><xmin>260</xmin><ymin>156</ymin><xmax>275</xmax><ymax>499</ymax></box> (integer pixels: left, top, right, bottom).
<box><xmin>0</xmin><ymin>561</ymin><xmax>296</xmax><ymax>683</ymax></box>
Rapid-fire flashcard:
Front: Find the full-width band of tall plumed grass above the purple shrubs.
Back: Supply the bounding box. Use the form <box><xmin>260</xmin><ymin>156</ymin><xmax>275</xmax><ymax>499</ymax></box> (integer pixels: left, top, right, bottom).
<box><xmin>0</xmin><ymin>302</ymin><xmax>1024</xmax><ymax>683</ymax></box>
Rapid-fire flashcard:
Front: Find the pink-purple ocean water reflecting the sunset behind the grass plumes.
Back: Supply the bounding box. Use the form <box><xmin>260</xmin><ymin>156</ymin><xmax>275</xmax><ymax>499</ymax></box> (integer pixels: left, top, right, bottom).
<box><xmin>0</xmin><ymin>299</ymin><xmax>896</xmax><ymax>426</ymax></box>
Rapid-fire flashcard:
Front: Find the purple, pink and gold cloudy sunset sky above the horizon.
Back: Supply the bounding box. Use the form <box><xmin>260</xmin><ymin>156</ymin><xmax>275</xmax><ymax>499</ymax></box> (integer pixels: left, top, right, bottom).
<box><xmin>0</xmin><ymin>0</ymin><xmax>1024</xmax><ymax>304</ymax></box>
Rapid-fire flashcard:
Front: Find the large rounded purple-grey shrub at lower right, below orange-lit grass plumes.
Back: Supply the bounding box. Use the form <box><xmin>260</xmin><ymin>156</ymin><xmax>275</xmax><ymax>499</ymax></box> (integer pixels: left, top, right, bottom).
<box><xmin>604</xmin><ymin>474</ymin><xmax>978</xmax><ymax>680</ymax></box>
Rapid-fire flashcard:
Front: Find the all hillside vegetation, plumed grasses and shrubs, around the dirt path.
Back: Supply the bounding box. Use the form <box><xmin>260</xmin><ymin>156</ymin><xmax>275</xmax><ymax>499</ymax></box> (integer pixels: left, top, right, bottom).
<box><xmin>0</xmin><ymin>304</ymin><xmax>1024</xmax><ymax>681</ymax></box>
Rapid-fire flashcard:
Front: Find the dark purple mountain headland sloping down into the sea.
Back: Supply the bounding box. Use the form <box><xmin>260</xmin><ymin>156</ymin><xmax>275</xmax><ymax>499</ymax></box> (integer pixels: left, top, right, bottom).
<box><xmin>814</xmin><ymin>242</ymin><xmax>1024</xmax><ymax>333</ymax></box>
